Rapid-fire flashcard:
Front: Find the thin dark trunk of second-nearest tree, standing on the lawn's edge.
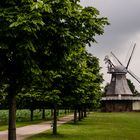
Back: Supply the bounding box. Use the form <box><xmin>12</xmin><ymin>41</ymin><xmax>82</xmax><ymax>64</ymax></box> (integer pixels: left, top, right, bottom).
<box><xmin>53</xmin><ymin>105</ymin><xmax>57</xmax><ymax>135</ymax></box>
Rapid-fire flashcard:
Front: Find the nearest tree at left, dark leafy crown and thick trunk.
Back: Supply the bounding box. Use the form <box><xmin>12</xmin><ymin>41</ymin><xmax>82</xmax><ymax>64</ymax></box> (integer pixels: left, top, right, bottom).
<box><xmin>0</xmin><ymin>0</ymin><xmax>48</xmax><ymax>140</ymax></box>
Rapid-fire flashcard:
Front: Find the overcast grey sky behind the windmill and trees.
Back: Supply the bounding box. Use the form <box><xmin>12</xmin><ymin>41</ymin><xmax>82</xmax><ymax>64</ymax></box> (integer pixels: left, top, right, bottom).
<box><xmin>81</xmin><ymin>0</ymin><xmax>140</xmax><ymax>91</ymax></box>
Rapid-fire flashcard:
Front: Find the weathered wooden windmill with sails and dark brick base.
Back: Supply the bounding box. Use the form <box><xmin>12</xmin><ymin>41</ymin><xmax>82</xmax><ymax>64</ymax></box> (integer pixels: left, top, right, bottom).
<box><xmin>102</xmin><ymin>45</ymin><xmax>140</xmax><ymax>112</ymax></box>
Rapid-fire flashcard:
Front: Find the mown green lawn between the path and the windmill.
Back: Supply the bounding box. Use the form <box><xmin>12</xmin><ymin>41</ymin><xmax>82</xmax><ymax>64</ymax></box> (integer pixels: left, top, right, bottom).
<box><xmin>27</xmin><ymin>112</ymin><xmax>140</xmax><ymax>140</ymax></box>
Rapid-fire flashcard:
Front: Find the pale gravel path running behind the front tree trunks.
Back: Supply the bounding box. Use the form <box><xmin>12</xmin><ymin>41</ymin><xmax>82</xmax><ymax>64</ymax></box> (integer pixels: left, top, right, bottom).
<box><xmin>0</xmin><ymin>115</ymin><xmax>73</xmax><ymax>140</ymax></box>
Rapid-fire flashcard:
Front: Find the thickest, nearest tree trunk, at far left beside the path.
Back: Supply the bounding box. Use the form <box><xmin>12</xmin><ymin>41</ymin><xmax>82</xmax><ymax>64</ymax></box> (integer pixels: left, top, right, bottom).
<box><xmin>8</xmin><ymin>92</ymin><xmax>16</xmax><ymax>140</ymax></box>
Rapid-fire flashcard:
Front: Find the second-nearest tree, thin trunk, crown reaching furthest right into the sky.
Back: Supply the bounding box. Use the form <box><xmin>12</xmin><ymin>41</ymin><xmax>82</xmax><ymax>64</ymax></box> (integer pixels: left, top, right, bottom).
<box><xmin>29</xmin><ymin>0</ymin><xmax>108</xmax><ymax>134</ymax></box>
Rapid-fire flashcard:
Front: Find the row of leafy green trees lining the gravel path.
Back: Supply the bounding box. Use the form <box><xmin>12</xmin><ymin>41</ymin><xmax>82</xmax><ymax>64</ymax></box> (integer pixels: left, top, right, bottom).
<box><xmin>0</xmin><ymin>0</ymin><xmax>108</xmax><ymax>140</ymax></box>
